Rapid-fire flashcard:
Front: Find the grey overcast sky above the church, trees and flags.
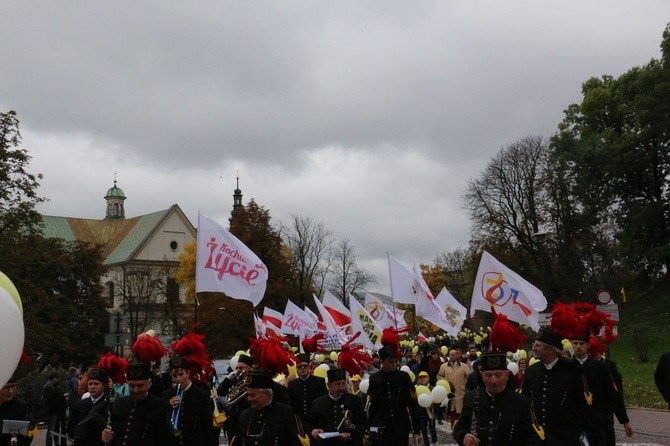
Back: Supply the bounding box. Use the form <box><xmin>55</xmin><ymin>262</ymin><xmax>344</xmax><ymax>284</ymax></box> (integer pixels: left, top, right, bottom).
<box><xmin>0</xmin><ymin>0</ymin><xmax>670</xmax><ymax>293</ymax></box>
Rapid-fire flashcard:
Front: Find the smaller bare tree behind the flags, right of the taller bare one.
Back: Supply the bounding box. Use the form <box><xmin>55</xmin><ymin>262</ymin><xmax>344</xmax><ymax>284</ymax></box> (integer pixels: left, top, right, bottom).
<box><xmin>330</xmin><ymin>239</ymin><xmax>377</xmax><ymax>307</ymax></box>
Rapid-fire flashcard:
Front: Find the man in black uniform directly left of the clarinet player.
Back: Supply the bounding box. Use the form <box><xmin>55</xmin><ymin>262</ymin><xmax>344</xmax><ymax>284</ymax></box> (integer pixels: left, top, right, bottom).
<box><xmin>101</xmin><ymin>362</ymin><xmax>172</xmax><ymax>446</ymax></box>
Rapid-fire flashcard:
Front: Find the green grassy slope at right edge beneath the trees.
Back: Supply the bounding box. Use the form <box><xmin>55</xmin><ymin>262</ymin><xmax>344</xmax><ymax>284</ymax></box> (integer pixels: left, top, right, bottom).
<box><xmin>609</xmin><ymin>282</ymin><xmax>670</xmax><ymax>409</ymax></box>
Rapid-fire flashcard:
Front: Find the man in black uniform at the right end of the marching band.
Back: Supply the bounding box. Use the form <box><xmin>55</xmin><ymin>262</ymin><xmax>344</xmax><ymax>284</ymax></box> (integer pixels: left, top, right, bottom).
<box><xmin>571</xmin><ymin>332</ymin><xmax>633</xmax><ymax>446</ymax></box>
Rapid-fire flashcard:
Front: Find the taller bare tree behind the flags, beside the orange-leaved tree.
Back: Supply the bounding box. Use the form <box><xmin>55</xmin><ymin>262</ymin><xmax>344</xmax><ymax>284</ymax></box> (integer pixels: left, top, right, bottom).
<box><xmin>281</xmin><ymin>215</ymin><xmax>333</xmax><ymax>306</ymax></box>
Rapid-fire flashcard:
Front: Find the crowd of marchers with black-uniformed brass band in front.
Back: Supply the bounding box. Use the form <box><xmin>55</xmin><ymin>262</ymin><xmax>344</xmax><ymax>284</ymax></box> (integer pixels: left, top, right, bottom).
<box><xmin>0</xmin><ymin>320</ymin><xmax>667</xmax><ymax>446</ymax></box>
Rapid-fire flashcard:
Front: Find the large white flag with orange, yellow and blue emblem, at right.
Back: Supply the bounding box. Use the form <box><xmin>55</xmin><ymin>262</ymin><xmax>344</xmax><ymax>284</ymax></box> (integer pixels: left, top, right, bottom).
<box><xmin>470</xmin><ymin>251</ymin><xmax>547</xmax><ymax>331</ymax></box>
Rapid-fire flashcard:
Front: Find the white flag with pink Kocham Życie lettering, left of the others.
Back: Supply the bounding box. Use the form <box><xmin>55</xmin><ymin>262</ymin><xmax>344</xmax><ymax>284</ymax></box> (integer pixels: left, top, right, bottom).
<box><xmin>195</xmin><ymin>213</ymin><xmax>268</xmax><ymax>307</ymax></box>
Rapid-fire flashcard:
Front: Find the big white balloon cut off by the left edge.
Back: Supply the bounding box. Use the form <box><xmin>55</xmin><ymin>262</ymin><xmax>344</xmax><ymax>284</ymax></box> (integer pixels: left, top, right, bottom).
<box><xmin>0</xmin><ymin>288</ymin><xmax>25</xmax><ymax>387</ymax></box>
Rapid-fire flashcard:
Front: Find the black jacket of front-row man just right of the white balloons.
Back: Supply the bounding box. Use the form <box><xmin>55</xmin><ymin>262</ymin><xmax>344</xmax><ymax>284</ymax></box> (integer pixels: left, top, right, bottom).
<box><xmin>454</xmin><ymin>387</ymin><xmax>540</xmax><ymax>446</ymax></box>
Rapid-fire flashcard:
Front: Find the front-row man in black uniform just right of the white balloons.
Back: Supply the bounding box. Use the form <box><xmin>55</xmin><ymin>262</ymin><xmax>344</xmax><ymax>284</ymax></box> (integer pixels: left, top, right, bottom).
<box><xmin>454</xmin><ymin>353</ymin><xmax>540</xmax><ymax>446</ymax></box>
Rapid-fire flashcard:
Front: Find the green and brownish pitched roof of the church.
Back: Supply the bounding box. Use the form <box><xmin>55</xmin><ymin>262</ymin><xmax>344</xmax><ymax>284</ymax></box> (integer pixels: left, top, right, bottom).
<box><xmin>42</xmin><ymin>208</ymin><xmax>178</xmax><ymax>265</ymax></box>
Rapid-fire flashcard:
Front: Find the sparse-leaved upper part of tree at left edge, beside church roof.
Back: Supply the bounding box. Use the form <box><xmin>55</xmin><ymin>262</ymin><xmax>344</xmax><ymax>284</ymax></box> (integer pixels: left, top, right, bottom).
<box><xmin>0</xmin><ymin>111</ymin><xmax>44</xmax><ymax>236</ymax></box>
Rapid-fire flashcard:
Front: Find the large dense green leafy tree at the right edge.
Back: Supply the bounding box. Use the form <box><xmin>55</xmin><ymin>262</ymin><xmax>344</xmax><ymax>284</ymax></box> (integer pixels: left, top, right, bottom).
<box><xmin>552</xmin><ymin>28</ymin><xmax>670</xmax><ymax>278</ymax></box>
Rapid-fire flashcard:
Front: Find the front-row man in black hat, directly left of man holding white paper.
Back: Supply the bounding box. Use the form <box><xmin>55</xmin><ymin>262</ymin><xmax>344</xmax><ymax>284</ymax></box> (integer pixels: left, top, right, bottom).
<box><xmin>231</xmin><ymin>371</ymin><xmax>300</xmax><ymax>446</ymax></box>
